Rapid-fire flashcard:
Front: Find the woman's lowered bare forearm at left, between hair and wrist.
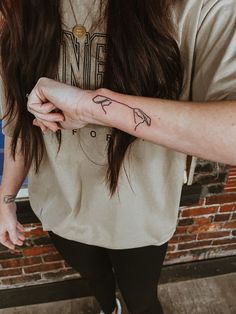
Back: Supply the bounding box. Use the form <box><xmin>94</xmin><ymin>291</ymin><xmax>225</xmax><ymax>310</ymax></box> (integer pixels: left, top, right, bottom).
<box><xmin>1</xmin><ymin>136</ymin><xmax>29</xmax><ymax>204</ymax></box>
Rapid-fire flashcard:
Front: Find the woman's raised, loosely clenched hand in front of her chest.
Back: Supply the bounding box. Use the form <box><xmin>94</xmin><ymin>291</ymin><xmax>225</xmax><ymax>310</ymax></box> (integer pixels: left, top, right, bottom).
<box><xmin>27</xmin><ymin>78</ymin><xmax>91</xmax><ymax>132</ymax></box>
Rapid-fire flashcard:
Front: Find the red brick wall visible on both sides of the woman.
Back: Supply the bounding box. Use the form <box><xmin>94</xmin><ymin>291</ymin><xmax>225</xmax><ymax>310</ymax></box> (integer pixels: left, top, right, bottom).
<box><xmin>0</xmin><ymin>164</ymin><xmax>236</xmax><ymax>289</ymax></box>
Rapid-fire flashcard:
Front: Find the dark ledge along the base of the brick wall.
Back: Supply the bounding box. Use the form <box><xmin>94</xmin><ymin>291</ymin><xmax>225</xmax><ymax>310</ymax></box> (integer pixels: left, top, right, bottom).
<box><xmin>0</xmin><ymin>256</ymin><xmax>236</xmax><ymax>309</ymax></box>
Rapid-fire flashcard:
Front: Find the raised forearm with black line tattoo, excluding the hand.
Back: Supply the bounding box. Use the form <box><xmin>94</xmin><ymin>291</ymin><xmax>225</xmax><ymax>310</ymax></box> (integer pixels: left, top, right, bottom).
<box><xmin>86</xmin><ymin>89</ymin><xmax>236</xmax><ymax>165</ymax></box>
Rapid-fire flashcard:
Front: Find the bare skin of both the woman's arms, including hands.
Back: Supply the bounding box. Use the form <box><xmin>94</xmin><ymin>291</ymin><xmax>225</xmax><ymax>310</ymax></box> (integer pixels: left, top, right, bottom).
<box><xmin>0</xmin><ymin>78</ymin><xmax>236</xmax><ymax>249</ymax></box>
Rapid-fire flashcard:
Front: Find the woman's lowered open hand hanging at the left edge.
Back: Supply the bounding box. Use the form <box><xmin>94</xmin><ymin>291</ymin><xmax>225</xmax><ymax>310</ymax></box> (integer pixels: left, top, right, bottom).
<box><xmin>0</xmin><ymin>203</ymin><xmax>25</xmax><ymax>250</ymax></box>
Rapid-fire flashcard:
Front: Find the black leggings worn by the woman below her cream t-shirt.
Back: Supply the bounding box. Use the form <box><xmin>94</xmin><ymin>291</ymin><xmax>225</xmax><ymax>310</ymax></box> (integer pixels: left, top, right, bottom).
<box><xmin>49</xmin><ymin>232</ymin><xmax>167</xmax><ymax>314</ymax></box>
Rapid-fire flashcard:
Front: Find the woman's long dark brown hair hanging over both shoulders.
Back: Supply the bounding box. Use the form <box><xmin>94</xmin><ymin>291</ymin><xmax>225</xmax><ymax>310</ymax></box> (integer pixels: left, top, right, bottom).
<box><xmin>0</xmin><ymin>0</ymin><xmax>183</xmax><ymax>195</ymax></box>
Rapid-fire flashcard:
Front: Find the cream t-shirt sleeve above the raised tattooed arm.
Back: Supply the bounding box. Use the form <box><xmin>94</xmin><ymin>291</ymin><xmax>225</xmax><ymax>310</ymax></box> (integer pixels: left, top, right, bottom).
<box><xmin>191</xmin><ymin>0</ymin><xmax>236</xmax><ymax>101</ymax></box>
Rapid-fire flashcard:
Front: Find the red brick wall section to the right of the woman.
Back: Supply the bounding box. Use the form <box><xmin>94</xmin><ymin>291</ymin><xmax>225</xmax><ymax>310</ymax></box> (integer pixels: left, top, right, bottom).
<box><xmin>165</xmin><ymin>161</ymin><xmax>236</xmax><ymax>264</ymax></box>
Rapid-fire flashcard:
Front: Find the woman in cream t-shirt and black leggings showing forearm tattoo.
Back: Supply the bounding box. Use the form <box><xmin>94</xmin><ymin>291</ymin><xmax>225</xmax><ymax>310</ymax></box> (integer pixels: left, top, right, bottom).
<box><xmin>0</xmin><ymin>0</ymin><xmax>236</xmax><ymax>314</ymax></box>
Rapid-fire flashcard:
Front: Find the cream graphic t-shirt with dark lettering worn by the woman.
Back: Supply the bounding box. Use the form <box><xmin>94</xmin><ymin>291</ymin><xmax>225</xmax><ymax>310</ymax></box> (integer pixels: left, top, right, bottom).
<box><xmin>0</xmin><ymin>0</ymin><xmax>236</xmax><ymax>249</ymax></box>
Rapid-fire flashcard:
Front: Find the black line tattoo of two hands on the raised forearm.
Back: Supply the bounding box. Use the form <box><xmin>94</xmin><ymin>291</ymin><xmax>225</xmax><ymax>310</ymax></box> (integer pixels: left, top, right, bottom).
<box><xmin>93</xmin><ymin>95</ymin><xmax>152</xmax><ymax>131</ymax></box>
